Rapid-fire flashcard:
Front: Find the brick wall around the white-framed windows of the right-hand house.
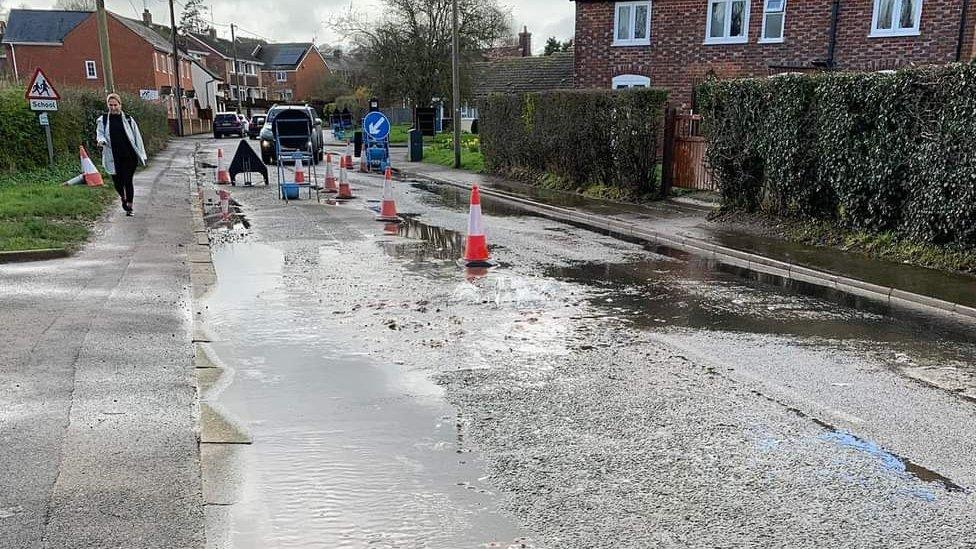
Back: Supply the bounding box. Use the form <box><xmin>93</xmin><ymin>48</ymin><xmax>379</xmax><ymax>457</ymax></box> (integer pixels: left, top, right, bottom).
<box><xmin>575</xmin><ymin>0</ymin><xmax>976</xmax><ymax>105</ymax></box>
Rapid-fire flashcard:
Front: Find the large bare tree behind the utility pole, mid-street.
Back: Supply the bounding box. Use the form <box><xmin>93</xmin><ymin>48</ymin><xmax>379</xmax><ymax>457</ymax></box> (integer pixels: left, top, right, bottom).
<box><xmin>338</xmin><ymin>0</ymin><xmax>511</xmax><ymax>105</ymax></box>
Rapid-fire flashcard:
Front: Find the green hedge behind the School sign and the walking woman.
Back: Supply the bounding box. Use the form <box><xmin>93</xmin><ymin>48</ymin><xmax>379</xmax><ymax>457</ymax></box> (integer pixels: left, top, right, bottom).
<box><xmin>0</xmin><ymin>86</ymin><xmax>169</xmax><ymax>172</ymax></box>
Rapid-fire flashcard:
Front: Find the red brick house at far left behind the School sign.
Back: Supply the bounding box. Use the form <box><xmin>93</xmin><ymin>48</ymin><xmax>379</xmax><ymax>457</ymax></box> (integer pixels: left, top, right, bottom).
<box><xmin>2</xmin><ymin>9</ymin><xmax>197</xmax><ymax>120</ymax></box>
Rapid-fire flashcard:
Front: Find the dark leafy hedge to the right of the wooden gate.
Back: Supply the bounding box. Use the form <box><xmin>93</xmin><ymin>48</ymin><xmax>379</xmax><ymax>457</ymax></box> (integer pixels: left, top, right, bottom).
<box><xmin>699</xmin><ymin>65</ymin><xmax>976</xmax><ymax>246</ymax></box>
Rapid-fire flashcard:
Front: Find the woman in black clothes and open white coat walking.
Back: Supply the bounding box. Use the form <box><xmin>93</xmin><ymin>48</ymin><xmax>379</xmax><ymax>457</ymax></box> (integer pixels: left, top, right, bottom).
<box><xmin>95</xmin><ymin>93</ymin><xmax>147</xmax><ymax>216</ymax></box>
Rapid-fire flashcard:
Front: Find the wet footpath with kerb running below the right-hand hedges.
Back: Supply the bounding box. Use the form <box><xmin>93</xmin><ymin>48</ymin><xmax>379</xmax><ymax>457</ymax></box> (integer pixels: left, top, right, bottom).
<box><xmin>393</xmin><ymin>151</ymin><xmax>976</xmax><ymax>322</ymax></box>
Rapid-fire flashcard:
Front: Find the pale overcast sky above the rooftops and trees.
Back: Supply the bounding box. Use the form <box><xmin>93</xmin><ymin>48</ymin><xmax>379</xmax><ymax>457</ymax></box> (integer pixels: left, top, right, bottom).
<box><xmin>15</xmin><ymin>0</ymin><xmax>575</xmax><ymax>52</ymax></box>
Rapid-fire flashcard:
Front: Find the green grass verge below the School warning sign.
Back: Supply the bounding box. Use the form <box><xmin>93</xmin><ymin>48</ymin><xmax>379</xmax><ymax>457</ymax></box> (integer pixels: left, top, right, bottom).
<box><xmin>0</xmin><ymin>161</ymin><xmax>115</xmax><ymax>251</ymax></box>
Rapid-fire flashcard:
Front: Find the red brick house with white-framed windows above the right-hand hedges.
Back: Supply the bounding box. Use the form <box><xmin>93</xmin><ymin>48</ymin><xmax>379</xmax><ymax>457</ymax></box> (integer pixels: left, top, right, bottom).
<box><xmin>575</xmin><ymin>0</ymin><xmax>976</xmax><ymax>105</ymax></box>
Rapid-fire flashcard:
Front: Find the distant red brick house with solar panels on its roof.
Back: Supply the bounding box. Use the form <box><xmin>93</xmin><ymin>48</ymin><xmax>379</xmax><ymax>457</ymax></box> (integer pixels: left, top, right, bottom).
<box><xmin>254</xmin><ymin>42</ymin><xmax>330</xmax><ymax>102</ymax></box>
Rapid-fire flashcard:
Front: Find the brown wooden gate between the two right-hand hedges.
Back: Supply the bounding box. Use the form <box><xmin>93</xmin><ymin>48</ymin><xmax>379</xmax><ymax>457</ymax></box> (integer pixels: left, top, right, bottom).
<box><xmin>664</xmin><ymin>108</ymin><xmax>716</xmax><ymax>191</ymax></box>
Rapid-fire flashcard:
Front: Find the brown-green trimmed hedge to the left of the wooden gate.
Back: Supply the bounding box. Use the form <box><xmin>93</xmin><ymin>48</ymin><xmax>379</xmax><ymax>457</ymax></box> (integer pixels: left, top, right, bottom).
<box><xmin>479</xmin><ymin>89</ymin><xmax>667</xmax><ymax>195</ymax></box>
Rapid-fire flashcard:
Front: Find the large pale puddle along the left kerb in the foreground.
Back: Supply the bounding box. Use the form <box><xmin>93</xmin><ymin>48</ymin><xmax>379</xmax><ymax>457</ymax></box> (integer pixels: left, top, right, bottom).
<box><xmin>201</xmin><ymin>243</ymin><xmax>532</xmax><ymax>549</ymax></box>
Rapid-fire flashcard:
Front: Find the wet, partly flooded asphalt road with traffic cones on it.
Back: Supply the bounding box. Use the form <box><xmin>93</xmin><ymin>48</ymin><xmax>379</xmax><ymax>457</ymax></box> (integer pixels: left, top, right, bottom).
<box><xmin>196</xmin><ymin>140</ymin><xmax>976</xmax><ymax>548</ymax></box>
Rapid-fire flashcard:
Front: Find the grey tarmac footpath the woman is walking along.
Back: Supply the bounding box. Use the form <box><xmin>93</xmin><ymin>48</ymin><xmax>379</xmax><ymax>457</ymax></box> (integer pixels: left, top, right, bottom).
<box><xmin>0</xmin><ymin>140</ymin><xmax>204</xmax><ymax>549</ymax></box>
